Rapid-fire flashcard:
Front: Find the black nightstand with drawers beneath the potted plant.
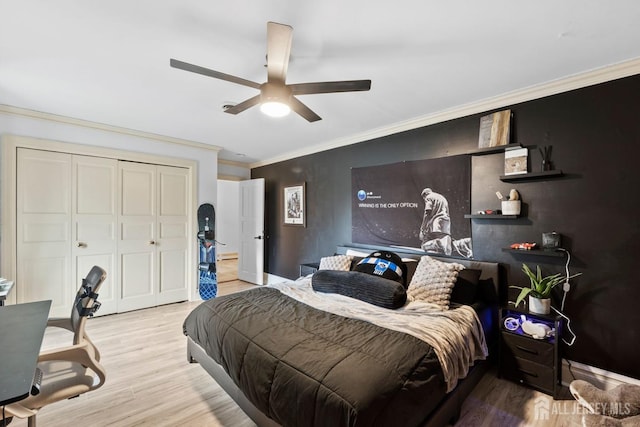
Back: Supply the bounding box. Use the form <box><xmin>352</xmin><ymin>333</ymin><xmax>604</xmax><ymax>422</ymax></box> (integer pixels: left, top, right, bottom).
<box><xmin>499</xmin><ymin>308</ymin><xmax>563</xmax><ymax>399</ymax></box>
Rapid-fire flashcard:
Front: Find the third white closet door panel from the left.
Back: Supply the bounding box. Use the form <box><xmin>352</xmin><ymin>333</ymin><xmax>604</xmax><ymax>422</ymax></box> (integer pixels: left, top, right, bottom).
<box><xmin>118</xmin><ymin>162</ymin><xmax>158</xmax><ymax>312</ymax></box>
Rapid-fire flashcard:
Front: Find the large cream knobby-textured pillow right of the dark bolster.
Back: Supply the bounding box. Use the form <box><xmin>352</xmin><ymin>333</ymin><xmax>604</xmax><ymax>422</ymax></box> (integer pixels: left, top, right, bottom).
<box><xmin>407</xmin><ymin>255</ymin><xmax>464</xmax><ymax>310</ymax></box>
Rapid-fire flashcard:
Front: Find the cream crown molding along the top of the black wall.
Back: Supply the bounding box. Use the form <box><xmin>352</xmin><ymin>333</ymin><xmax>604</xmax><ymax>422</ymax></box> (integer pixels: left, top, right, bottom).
<box><xmin>250</xmin><ymin>58</ymin><xmax>640</xmax><ymax>169</ymax></box>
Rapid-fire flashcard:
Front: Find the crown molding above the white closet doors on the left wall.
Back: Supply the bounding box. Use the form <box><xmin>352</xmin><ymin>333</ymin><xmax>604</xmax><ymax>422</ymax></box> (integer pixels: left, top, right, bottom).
<box><xmin>0</xmin><ymin>104</ymin><xmax>222</xmax><ymax>152</ymax></box>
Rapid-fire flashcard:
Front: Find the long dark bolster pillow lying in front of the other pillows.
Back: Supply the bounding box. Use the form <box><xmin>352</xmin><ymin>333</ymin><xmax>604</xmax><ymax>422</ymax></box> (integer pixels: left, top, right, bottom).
<box><xmin>311</xmin><ymin>270</ymin><xmax>407</xmax><ymax>309</ymax></box>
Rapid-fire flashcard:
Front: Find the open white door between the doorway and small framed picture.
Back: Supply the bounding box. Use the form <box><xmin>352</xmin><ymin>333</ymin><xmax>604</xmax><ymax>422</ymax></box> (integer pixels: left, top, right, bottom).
<box><xmin>238</xmin><ymin>178</ymin><xmax>264</xmax><ymax>285</ymax></box>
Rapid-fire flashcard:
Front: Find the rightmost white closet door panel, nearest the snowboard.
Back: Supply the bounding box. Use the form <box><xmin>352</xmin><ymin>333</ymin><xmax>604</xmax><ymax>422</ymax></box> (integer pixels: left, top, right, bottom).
<box><xmin>156</xmin><ymin>166</ymin><xmax>191</xmax><ymax>304</ymax></box>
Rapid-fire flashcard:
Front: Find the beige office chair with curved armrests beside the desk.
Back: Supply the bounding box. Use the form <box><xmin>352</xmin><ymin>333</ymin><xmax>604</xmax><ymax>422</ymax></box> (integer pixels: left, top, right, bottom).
<box><xmin>4</xmin><ymin>266</ymin><xmax>107</xmax><ymax>427</ymax></box>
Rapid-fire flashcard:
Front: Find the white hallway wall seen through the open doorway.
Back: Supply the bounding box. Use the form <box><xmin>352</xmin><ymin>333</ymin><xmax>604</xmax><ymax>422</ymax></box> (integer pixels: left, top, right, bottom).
<box><xmin>216</xmin><ymin>180</ymin><xmax>240</xmax><ymax>255</ymax></box>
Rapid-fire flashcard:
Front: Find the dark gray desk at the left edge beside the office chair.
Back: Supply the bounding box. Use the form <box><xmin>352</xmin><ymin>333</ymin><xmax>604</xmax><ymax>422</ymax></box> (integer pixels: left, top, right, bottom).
<box><xmin>0</xmin><ymin>301</ymin><xmax>51</xmax><ymax>405</ymax></box>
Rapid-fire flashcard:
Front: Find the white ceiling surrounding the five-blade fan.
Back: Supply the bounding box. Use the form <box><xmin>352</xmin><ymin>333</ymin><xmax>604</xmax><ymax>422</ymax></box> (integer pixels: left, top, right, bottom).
<box><xmin>0</xmin><ymin>0</ymin><xmax>640</xmax><ymax>163</ymax></box>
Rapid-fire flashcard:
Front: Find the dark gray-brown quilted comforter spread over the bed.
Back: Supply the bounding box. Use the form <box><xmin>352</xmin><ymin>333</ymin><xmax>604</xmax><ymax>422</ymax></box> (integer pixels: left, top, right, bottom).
<box><xmin>184</xmin><ymin>288</ymin><xmax>446</xmax><ymax>427</ymax></box>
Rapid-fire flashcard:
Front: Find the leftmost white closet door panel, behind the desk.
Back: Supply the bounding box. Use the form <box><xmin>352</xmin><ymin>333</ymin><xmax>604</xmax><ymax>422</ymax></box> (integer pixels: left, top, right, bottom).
<box><xmin>14</xmin><ymin>148</ymin><xmax>75</xmax><ymax>317</ymax></box>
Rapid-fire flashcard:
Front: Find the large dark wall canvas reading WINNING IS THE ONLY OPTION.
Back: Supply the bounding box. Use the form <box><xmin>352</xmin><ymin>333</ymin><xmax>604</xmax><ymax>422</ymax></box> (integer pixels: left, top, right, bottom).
<box><xmin>351</xmin><ymin>156</ymin><xmax>473</xmax><ymax>258</ymax></box>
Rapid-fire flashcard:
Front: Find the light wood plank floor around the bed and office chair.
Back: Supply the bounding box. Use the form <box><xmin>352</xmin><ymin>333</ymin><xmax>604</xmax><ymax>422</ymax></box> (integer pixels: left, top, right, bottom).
<box><xmin>6</xmin><ymin>266</ymin><xmax>581</xmax><ymax>427</ymax></box>
